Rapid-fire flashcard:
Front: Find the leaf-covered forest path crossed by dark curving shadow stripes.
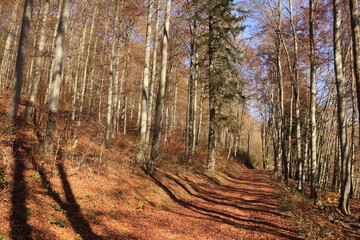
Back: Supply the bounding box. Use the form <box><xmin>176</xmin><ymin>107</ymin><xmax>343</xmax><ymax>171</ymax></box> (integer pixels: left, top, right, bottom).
<box><xmin>131</xmin><ymin>169</ymin><xmax>301</xmax><ymax>240</ymax></box>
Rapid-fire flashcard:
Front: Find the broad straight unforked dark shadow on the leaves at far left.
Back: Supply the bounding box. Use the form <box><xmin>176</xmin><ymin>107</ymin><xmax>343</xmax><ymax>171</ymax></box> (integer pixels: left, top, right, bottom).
<box><xmin>10</xmin><ymin>133</ymin><xmax>32</xmax><ymax>239</ymax></box>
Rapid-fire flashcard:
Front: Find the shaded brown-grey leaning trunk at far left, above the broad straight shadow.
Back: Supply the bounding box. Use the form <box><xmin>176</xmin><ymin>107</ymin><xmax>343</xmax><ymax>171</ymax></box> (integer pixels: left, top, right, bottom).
<box><xmin>10</xmin><ymin>0</ymin><xmax>32</xmax><ymax>120</ymax></box>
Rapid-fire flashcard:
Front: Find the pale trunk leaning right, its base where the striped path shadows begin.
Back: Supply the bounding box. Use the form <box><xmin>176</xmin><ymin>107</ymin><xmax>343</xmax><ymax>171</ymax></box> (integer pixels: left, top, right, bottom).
<box><xmin>146</xmin><ymin>0</ymin><xmax>171</xmax><ymax>174</ymax></box>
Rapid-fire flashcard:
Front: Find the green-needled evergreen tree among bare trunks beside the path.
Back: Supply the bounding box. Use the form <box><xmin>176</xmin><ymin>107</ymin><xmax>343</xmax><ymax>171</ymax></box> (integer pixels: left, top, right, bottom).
<box><xmin>201</xmin><ymin>0</ymin><xmax>244</xmax><ymax>172</ymax></box>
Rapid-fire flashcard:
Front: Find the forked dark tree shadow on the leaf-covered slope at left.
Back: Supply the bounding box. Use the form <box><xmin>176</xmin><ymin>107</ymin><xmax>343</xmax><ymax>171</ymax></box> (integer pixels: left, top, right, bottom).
<box><xmin>32</xmin><ymin>147</ymin><xmax>103</xmax><ymax>240</ymax></box>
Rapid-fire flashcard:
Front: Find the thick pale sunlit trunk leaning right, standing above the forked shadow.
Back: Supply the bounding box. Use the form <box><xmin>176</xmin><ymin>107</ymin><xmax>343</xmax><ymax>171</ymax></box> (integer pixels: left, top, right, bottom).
<box><xmin>45</xmin><ymin>0</ymin><xmax>70</xmax><ymax>150</ymax></box>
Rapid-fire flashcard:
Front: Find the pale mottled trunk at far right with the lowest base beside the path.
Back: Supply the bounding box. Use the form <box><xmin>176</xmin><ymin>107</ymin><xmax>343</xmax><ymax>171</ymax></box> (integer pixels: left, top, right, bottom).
<box><xmin>333</xmin><ymin>0</ymin><xmax>351</xmax><ymax>215</ymax></box>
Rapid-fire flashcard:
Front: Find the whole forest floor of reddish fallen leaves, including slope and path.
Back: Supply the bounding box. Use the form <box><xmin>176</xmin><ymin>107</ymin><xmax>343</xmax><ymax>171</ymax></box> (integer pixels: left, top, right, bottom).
<box><xmin>0</xmin><ymin>96</ymin><xmax>360</xmax><ymax>240</ymax></box>
